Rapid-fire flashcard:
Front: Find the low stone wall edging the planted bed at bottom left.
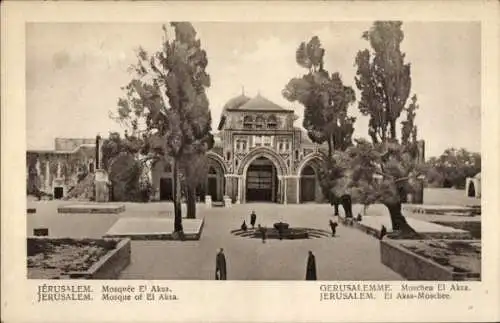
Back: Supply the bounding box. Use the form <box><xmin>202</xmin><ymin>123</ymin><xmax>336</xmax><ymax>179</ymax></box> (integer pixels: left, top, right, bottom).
<box><xmin>68</xmin><ymin>239</ymin><xmax>131</xmax><ymax>279</ymax></box>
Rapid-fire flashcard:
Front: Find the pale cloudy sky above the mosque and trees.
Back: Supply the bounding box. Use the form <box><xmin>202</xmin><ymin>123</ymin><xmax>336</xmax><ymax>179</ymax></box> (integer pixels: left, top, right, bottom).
<box><xmin>26</xmin><ymin>22</ymin><xmax>481</xmax><ymax>157</ymax></box>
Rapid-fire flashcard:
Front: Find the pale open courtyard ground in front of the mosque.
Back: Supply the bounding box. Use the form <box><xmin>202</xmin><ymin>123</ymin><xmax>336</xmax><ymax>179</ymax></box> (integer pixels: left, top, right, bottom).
<box><xmin>27</xmin><ymin>190</ymin><xmax>480</xmax><ymax>280</ymax></box>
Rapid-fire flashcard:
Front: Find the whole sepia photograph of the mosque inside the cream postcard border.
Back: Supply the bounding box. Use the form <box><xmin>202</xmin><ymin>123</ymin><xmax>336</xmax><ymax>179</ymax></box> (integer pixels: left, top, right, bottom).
<box><xmin>25</xmin><ymin>19</ymin><xmax>482</xmax><ymax>281</ymax></box>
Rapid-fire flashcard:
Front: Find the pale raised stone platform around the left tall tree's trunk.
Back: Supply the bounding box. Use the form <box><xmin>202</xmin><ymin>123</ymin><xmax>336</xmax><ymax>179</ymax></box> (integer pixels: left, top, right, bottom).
<box><xmin>104</xmin><ymin>217</ymin><xmax>204</xmax><ymax>240</ymax></box>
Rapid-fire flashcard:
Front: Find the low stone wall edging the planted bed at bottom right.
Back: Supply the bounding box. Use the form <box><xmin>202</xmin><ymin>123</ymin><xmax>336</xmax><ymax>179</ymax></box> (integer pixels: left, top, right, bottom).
<box><xmin>380</xmin><ymin>240</ymin><xmax>480</xmax><ymax>281</ymax></box>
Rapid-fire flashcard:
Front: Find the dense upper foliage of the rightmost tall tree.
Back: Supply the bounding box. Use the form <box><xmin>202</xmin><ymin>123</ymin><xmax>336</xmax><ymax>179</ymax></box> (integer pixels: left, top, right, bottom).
<box><xmin>355</xmin><ymin>21</ymin><xmax>411</xmax><ymax>143</ymax></box>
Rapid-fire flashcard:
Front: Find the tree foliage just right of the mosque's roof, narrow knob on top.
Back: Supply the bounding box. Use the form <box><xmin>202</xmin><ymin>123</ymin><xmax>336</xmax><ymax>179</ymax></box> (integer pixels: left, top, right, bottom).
<box><xmin>282</xmin><ymin>36</ymin><xmax>356</xmax><ymax>156</ymax></box>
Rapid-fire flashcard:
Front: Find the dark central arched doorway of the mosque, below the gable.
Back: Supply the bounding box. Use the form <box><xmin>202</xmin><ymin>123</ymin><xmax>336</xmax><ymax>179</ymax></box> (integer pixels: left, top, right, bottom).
<box><xmin>245</xmin><ymin>157</ymin><xmax>279</xmax><ymax>202</ymax></box>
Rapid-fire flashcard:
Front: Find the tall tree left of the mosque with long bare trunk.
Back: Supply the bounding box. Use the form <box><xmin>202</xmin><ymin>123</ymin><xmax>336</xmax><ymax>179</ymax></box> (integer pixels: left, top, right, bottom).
<box><xmin>113</xmin><ymin>22</ymin><xmax>213</xmax><ymax>234</ymax></box>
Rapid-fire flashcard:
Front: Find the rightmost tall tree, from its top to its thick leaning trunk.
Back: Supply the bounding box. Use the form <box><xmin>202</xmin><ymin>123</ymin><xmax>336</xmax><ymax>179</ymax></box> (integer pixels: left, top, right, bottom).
<box><xmin>352</xmin><ymin>21</ymin><xmax>421</xmax><ymax>234</ymax></box>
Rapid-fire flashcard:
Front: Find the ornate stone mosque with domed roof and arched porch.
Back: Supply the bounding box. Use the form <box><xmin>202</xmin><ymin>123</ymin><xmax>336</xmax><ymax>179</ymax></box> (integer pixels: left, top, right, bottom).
<box><xmin>152</xmin><ymin>95</ymin><xmax>325</xmax><ymax>204</ymax></box>
